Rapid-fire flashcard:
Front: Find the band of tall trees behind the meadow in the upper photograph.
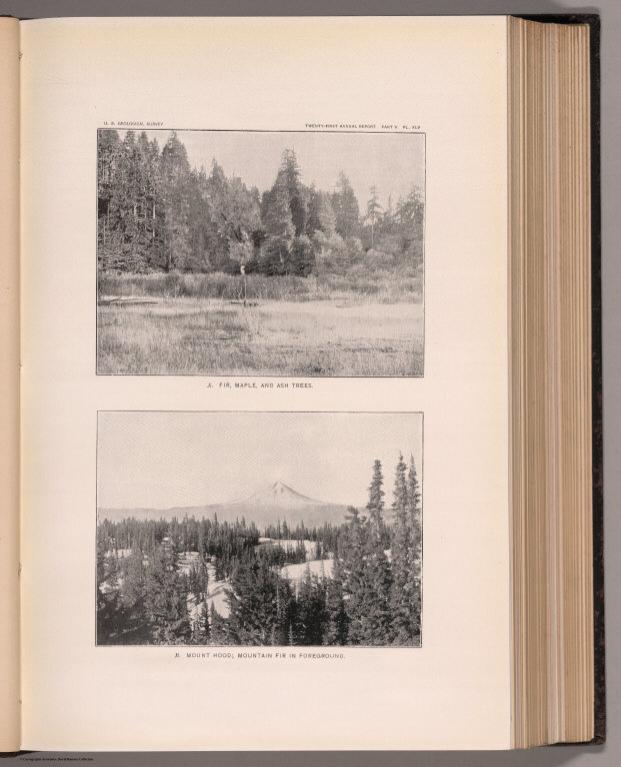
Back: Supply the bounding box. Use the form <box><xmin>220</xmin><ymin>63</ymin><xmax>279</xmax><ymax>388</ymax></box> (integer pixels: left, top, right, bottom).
<box><xmin>97</xmin><ymin>129</ymin><xmax>424</xmax><ymax>276</ymax></box>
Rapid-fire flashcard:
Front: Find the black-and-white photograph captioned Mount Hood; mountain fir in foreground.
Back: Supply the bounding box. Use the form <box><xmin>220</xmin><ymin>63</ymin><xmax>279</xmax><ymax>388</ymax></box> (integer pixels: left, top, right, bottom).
<box><xmin>96</xmin><ymin>411</ymin><xmax>423</xmax><ymax>647</ymax></box>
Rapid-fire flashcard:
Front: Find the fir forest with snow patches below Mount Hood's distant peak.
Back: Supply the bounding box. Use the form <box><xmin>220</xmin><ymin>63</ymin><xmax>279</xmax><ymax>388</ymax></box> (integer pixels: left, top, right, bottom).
<box><xmin>97</xmin><ymin>457</ymin><xmax>422</xmax><ymax>646</ymax></box>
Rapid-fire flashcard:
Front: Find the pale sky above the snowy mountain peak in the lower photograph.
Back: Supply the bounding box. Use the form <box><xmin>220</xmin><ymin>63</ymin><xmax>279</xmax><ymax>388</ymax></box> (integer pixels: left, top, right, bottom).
<box><xmin>97</xmin><ymin>411</ymin><xmax>423</xmax><ymax>508</ymax></box>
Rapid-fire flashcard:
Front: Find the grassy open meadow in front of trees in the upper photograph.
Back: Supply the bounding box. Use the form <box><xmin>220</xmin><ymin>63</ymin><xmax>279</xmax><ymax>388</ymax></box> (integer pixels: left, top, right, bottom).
<box><xmin>97</xmin><ymin>275</ymin><xmax>423</xmax><ymax>376</ymax></box>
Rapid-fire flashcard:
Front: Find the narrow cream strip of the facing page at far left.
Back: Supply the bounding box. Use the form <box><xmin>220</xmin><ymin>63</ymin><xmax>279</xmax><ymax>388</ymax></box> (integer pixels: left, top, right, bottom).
<box><xmin>0</xmin><ymin>18</ymin><xmax>21</xmax><ymax>752</ymax></box>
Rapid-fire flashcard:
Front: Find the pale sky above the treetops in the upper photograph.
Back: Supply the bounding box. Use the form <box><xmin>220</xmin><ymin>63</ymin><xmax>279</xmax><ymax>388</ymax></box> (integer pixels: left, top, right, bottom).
<box><xmin>120</xmin><ymin>130</ymin><xmax>425</xmax><ymax>211</ymax></box>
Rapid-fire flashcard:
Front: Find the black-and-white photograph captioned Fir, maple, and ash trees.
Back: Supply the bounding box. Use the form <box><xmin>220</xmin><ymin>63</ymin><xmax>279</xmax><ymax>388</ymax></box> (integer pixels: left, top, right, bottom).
<box><xmin>97</xmin><ymin>128</ymin><xmax>425</xmax><ymax>377</ymax></box>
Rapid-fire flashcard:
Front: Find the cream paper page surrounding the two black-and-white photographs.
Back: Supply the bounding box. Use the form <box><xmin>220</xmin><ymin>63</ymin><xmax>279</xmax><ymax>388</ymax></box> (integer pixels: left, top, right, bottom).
<box><xmin>22</xmin><ymin>17</ymin><xmax>510</xmax><ymax>750</ymax></box>
